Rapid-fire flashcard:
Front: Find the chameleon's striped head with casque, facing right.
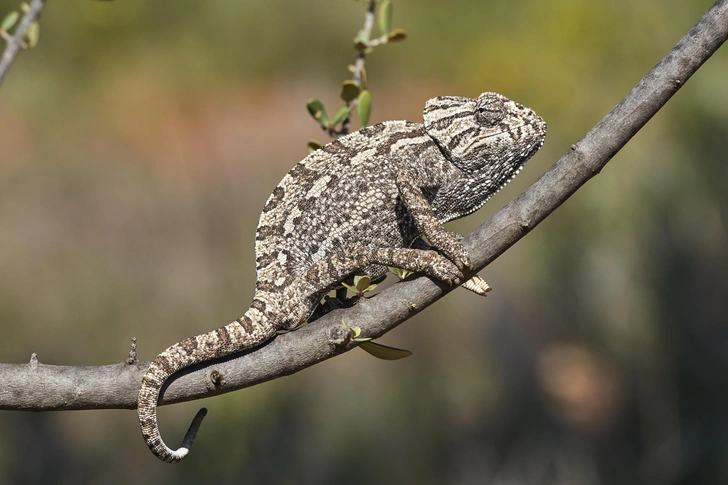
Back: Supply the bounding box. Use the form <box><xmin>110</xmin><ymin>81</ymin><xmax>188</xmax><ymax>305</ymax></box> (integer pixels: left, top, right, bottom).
<box><xmin>424</xmin><ymin>93</ymin><xmax>546</xmax><ymax>187</ymax></box>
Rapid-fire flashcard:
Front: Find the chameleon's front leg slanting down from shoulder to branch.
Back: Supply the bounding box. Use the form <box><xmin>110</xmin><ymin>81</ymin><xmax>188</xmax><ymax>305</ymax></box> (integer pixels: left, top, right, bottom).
<box><xmin>397</xmin><ymin>171</ymin><xmax>471</xmax><ymax>271</ymax></box>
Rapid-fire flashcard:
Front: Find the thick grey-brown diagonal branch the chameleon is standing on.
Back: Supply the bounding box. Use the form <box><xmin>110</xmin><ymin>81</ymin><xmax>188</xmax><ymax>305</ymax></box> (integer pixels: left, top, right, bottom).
<box><xmin>0</xmin><ymin>0</ymin><xmax>728</xmax><ymax>411</ymax></box>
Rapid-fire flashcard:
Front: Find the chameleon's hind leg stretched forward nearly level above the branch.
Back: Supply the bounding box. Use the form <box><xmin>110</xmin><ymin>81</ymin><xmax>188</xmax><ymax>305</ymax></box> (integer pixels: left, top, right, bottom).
<box><xmin>298</xmin><ymin>248</ymin><xmax>463</xmax><ymax>287</ymax></box>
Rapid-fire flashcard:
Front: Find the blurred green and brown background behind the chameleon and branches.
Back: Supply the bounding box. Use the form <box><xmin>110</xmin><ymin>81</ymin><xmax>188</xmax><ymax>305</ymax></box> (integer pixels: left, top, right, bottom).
<box><xmin>0</xmin><ymin>0</ymin><xmax>728</xmax><ymax>485</ymax></box>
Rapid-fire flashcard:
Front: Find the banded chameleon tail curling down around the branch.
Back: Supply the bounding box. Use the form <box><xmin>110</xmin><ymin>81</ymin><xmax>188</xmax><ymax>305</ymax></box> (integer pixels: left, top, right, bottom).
<box><xmin>137</xmin><ymin>298</ymin><xmax>276</xmax><ymax>463</ymax></box>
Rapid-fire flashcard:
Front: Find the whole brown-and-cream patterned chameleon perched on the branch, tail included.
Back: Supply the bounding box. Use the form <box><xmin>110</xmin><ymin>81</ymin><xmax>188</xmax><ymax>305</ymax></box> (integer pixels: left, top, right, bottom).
<box><xmin>138</xmin><ymin>93</ymin><xmax>546</xmax><ymax>463</ymax></box>
